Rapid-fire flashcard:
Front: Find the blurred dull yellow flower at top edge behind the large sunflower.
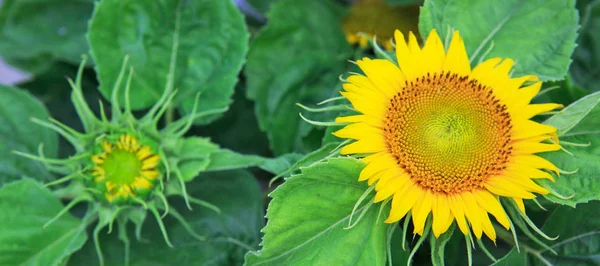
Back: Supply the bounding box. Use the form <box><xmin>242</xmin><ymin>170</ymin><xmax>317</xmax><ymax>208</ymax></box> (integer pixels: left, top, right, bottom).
<box><xmin>342</xmin><ymin>0</ymin><xmax>419</xmax><ymax>51</ymax></box>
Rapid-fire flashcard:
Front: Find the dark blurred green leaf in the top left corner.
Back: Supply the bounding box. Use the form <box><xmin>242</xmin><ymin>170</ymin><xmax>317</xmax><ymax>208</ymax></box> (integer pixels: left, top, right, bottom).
<box><xmin>0</xmin><ymin>0</ymin><xmax>93</xmax><ymax>72</ymax></box>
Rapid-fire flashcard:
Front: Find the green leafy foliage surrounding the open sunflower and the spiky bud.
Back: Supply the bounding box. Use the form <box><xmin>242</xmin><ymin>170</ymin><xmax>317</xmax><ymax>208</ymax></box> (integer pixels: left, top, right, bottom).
<box><xmin>0</xmin><ymin>0</ymin><xmax>600</xmax><ymax>266</ymax></box>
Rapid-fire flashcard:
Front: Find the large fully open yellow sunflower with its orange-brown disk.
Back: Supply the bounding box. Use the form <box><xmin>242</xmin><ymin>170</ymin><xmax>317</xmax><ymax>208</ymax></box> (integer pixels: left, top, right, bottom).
<box><xmin>334</xmin><ymin>30</ymin><xmax>562</xmax><ymax>241</ymax></box>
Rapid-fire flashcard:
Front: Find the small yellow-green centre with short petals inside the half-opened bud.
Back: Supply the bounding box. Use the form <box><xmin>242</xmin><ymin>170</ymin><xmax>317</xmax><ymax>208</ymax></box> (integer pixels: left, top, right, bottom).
<box><xmin>92</xmin><ymin>134</ymin><xmax>160</xmax><ymax>202</ymax></box>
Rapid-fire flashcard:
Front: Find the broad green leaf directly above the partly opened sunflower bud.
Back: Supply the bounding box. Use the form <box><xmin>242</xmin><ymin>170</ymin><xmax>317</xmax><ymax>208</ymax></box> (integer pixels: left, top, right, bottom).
<box><xmin>88</xmin><ymin>0</ymin><xmax>248</xmax><ymax>123</ymax></box>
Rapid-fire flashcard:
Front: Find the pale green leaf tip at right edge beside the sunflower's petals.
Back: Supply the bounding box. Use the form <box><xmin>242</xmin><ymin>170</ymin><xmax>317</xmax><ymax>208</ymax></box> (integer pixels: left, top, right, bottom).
<box><xmin>544</xmin><ymin>92</ymin><xmax>600</xmax><ymax>136</ymax></box>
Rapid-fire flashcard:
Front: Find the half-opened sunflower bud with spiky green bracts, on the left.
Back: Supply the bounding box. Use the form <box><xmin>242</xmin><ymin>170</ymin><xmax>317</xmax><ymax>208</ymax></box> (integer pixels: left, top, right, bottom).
<box><xmin>15</xmin><ymin>57</ymin><xmax>222</xmax><ymax>265</ymax></box>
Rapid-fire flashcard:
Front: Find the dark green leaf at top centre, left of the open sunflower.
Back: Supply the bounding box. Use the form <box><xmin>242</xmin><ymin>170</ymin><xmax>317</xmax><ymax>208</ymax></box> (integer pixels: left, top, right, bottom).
<box><xmin>244</xmin><ymin>0</ymin><xmax>351</xmax><ymax>154</ymax></box>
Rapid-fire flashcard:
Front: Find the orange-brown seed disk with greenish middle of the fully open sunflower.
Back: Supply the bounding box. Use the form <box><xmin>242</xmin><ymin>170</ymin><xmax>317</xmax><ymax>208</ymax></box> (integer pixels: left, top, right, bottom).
<box><xmin>385</xmin><ymin>73</ymin><xmax>512</xmax><ymax>193</ymax></box>
